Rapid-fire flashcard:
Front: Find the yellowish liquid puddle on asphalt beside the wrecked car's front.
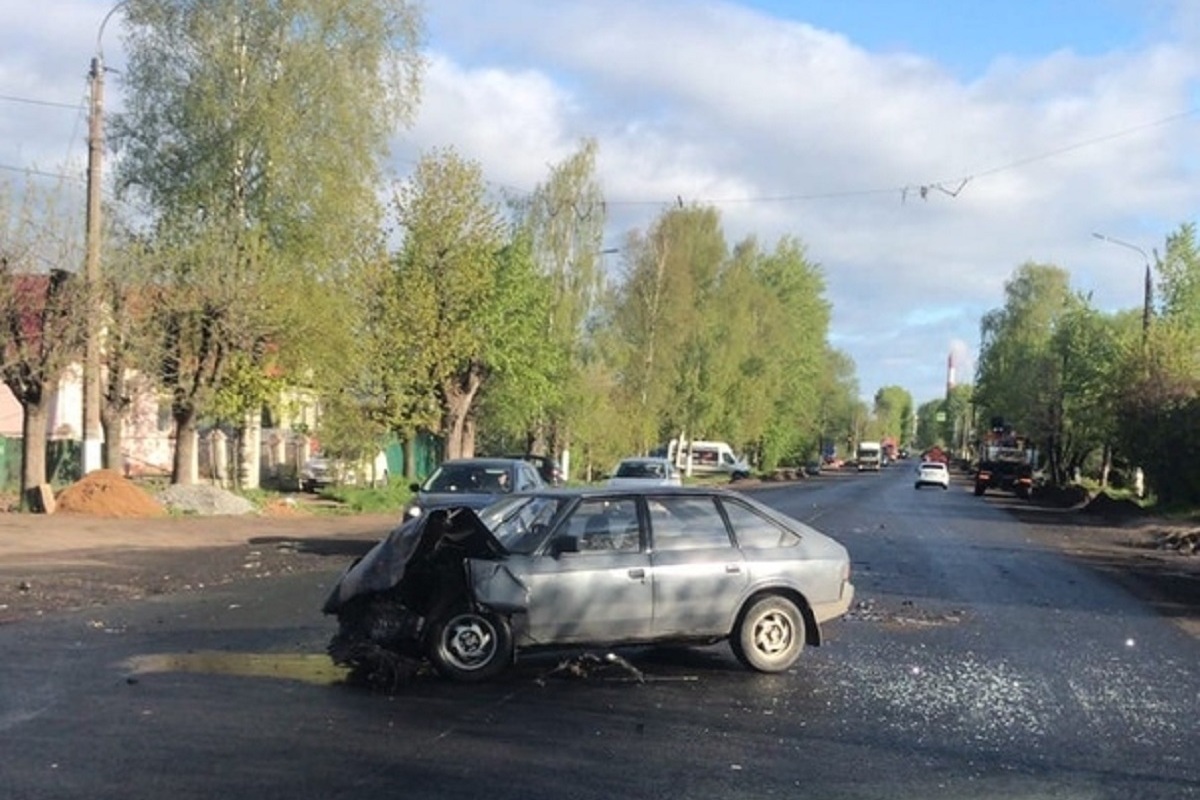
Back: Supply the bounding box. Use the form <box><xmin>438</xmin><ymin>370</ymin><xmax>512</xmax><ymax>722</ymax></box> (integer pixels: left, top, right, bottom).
<box><xmin>124</xmin><ymin>650</ymin><xmax>348</xmax><ymax>685</ymax></box>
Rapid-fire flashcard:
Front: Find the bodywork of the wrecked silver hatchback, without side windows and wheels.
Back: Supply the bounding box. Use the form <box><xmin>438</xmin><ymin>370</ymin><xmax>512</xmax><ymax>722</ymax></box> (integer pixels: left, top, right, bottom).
<box><xmin>325</xmin><ymin>489</ymin><xmax>854</xmax><ymax>648</ymax></box>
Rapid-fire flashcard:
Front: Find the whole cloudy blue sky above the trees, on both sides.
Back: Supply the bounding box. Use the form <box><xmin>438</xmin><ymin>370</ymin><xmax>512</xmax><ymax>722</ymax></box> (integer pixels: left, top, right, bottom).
<box><xmin>0</xmin><ymin>0</ymin><xmax>1200</xmax><ymax>402</ymax></box>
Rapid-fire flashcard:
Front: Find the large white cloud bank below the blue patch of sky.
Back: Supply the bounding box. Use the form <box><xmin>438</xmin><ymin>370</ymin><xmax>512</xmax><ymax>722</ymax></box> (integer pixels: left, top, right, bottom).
<box><xmin>396</xmin><ymin>1</ymin><xmax>1198</xmax><ymax>401</ymax></box>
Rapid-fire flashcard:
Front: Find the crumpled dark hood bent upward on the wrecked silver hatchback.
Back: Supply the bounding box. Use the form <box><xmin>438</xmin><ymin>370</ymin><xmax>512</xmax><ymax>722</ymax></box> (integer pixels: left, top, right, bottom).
<box><xmin>322</xmin><ymin>506</ymin><xmax>508</xmax><ymax>614</ymax></box>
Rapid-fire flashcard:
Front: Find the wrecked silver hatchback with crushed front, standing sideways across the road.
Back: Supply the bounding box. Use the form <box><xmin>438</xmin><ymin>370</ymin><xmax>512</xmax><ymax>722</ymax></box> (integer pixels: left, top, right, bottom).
<box><xmin>324</xmin><ymin>487</ymin><xmax>854</xmax><ymax>685</ymax></box>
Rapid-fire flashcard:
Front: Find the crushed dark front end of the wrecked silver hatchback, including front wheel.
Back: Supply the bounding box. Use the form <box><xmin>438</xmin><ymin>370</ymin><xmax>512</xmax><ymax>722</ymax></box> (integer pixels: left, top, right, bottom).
<box><xmin>323</xmin><ymin>509</ymin><xmax>511</xmax><ymax>691</ymax></box>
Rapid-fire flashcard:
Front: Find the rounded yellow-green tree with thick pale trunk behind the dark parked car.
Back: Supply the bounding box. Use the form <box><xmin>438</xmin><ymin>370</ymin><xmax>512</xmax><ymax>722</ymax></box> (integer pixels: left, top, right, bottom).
<box><xmin>391</xmin><ymin>150</ymin><xmax>551</xmax><ymax>458</ymax></box>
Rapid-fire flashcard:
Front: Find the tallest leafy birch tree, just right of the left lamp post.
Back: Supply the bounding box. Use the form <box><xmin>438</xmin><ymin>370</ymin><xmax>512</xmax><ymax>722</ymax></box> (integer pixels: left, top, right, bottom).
<box><xmin>113</xmin><ymin>0</ymin><xmax>421</xmax><ymax>482</ymax></box>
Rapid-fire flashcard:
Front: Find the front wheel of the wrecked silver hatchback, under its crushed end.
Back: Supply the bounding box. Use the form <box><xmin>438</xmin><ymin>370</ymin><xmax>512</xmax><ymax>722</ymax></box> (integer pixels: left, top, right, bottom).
<box><xmin>428</xmin><ymin>608</ymin><xmax>514</xmax><ymax>682</ymax></box>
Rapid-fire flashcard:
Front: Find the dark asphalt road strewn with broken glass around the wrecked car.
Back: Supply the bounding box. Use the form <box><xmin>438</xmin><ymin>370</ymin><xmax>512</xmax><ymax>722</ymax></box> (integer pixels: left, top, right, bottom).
<box><xmin>0</xmin><ymin>467</ymin><xmax>1200</xmax><ymax>800</ymax></box>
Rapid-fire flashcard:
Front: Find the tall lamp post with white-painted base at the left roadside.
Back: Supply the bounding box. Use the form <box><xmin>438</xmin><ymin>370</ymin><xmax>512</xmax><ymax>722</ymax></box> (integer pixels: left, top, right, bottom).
<box><xmin>82</xmin><ymin>0</ymin><xmax>130</xmax><ymax>474</ymax></box>
